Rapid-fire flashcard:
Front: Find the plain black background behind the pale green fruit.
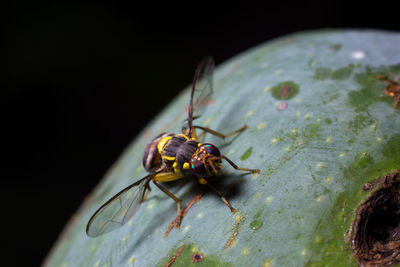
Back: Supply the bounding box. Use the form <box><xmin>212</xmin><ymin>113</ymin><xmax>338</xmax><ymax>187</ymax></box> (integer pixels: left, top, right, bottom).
<box><xmin>0</xmin><ymin>1</ymin><xmax>400</xmax><ymax>266</ymax></box>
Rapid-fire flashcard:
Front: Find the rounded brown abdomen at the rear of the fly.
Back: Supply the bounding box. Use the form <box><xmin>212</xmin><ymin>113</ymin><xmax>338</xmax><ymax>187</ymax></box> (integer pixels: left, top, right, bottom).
<box><xmin>142</xmin><ymin>133</ymin><xmax>174</xmax><ymax>172</ymax></box>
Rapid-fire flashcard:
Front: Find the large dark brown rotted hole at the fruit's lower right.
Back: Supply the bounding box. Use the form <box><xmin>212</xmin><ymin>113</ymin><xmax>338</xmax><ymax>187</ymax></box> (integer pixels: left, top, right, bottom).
<box><xmin>351</xmin><ymin>170</ymin><xmax>400</xmax><ymax>266</ymax></box>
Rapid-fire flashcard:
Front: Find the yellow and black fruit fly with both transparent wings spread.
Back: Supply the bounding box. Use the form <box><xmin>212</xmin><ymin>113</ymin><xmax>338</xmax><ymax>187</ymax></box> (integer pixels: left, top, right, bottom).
<box><xmin>86</xmin><ymin>57</ymin><xmax>260</xmax><ymax>237</ymax></box>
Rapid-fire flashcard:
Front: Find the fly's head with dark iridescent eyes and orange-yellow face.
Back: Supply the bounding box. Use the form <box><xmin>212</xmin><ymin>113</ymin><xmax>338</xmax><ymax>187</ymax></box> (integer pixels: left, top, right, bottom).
<box><xmin>190</xmin><ymin>143</ymin><xmax>222</xmax><ymax>178</ymax></box>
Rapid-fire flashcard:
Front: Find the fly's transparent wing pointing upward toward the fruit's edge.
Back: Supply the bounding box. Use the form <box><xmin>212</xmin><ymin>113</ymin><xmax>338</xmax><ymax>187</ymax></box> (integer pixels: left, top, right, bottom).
<box><xmin>187</xmin><ymin>57</ymin><xmax>215</xmax><ymax>136</ymax></box>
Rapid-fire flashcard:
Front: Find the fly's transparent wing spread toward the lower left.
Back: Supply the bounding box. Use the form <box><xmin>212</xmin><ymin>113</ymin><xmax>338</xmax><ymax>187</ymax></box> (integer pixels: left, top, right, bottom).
<box><xmin>86</xmin><ymin>175</ymin><xmax>152</xmax><ymax>237</ymax></box>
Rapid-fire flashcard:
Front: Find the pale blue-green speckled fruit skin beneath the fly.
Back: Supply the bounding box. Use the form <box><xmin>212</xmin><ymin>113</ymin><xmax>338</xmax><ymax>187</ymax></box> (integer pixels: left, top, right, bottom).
<box><xmin>45</xmin><ymin>30</ymin><xmax>400</xmax><ymax>266</ymax></box>
